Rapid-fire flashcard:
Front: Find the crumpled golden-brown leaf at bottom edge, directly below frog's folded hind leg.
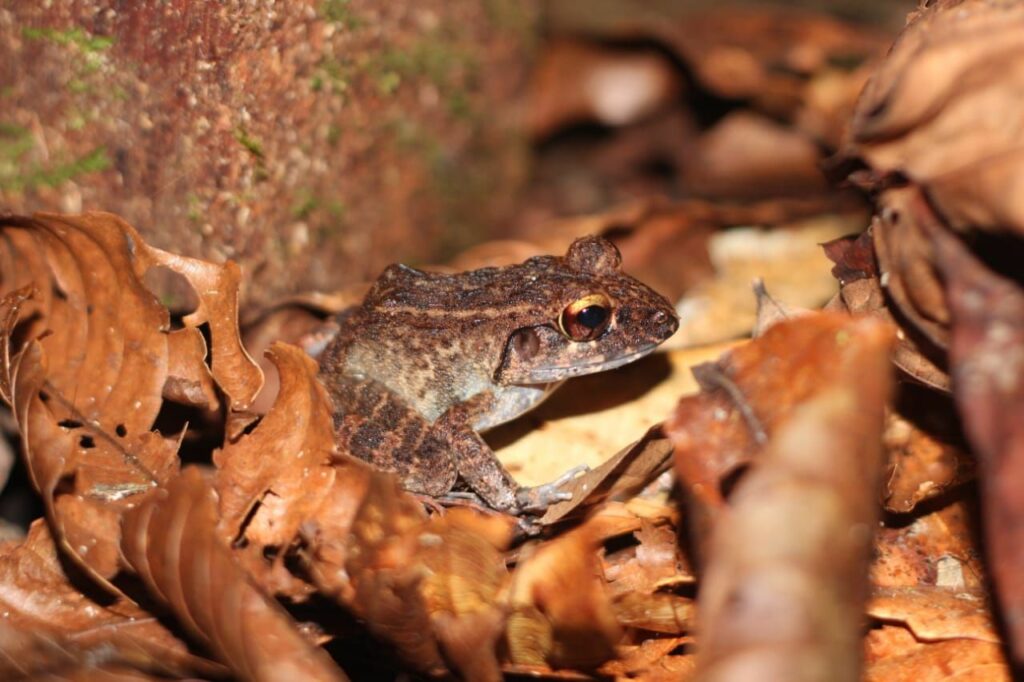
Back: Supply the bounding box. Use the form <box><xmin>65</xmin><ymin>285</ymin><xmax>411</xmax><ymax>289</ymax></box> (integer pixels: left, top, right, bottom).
<box><xmin>305</xmin><ymin>457</ymin><xmax>514</xmax><ymax>680</ymax></box>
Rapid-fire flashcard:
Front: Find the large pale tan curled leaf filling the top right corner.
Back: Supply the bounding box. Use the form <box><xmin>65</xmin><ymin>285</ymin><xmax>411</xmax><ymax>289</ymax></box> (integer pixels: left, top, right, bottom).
<box><xmin>850</xmin><ymin>0</ymin><xmax>1024</xmax><ymax>233</ymax></box>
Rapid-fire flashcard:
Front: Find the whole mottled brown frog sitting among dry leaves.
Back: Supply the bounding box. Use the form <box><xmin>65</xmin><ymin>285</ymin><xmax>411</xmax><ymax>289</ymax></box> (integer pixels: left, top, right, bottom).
<box><xmin>321</xmin><ymin>237</ymin><xmax>679</xmax><ymax>513</ymax></box>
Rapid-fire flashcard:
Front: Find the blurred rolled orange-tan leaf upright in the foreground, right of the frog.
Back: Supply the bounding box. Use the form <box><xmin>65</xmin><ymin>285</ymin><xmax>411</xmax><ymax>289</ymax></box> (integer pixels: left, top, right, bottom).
<box><xmin>688</xmin><ymin>313</ymin><xmax>892</xmax><ymax>680</ymax></box>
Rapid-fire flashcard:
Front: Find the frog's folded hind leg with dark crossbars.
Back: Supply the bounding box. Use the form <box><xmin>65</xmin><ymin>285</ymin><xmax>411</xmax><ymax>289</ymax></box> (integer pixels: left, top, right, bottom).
<box><xmin>331</xmin><ymin>379</ymin><xmax>458</xmax><ymax>497</ymax></box>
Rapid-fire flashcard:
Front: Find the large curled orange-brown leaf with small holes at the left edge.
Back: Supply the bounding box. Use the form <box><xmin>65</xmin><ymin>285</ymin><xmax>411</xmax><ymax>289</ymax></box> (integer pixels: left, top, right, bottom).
<box><xmin>0</xmin><ymin>213</ymin><xmax>258</xmax><ymax>587</ymax></box>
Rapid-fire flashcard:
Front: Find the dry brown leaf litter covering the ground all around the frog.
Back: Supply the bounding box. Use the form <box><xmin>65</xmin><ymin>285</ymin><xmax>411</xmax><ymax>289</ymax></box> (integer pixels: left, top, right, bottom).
<box><xmin>0</xmin><ymin>0</ymin><xmax>1024</xmax><ymax>680</ymax></box>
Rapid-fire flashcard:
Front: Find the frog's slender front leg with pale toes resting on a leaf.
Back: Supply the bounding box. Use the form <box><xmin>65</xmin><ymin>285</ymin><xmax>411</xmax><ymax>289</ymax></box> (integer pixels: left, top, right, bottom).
<box><xmin>432</xmin><ymin>393</ymin><xmax>578</xmax><ymax>513</ymax></box>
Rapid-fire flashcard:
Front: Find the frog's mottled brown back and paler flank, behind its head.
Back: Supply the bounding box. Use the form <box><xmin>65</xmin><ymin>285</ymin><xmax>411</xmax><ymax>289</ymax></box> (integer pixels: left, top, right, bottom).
<box><xmin>322</xmin><ymin>258</ymin><xmax>557</xmax><ymax>421</ymax></box>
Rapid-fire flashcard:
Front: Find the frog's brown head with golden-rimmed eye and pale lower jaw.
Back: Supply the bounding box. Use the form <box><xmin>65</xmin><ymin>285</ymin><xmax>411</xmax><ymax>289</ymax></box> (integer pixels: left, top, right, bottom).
<box><xmin>495</xmin><ymin>237</ymin><xmax>679</xmax><ymax>384</ymax></box>
